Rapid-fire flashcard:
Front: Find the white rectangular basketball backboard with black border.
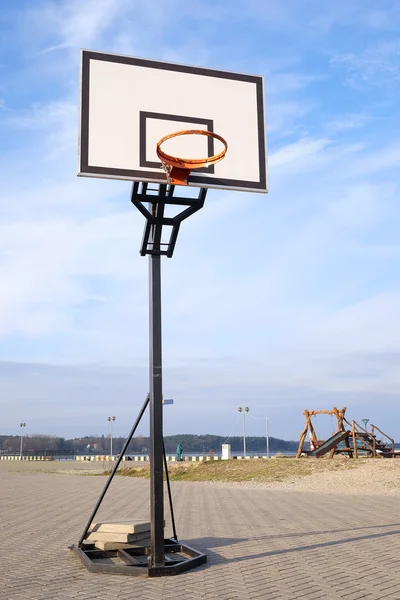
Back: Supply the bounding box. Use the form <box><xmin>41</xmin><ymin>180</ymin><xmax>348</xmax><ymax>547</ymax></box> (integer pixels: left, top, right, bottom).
<box><xmin>78</xmin><ymin>50</ymin><xmax>268</xmax><ymax>193</ymax></box>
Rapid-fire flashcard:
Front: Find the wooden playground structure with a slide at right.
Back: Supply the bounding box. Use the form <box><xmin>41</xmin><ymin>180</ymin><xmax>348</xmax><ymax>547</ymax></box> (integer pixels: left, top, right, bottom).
<box><xmin>296</xmin><ymin>406</ymin><xmax>400</xmax><ymax>458</ymax></box>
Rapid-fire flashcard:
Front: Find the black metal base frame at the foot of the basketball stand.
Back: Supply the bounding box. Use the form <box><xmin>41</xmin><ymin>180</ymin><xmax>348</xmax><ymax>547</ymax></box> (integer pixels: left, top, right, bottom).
<box><xmin>71</xmin><ymin>538</ymin><xmax>207</xmax><ymax>577</ymax></box>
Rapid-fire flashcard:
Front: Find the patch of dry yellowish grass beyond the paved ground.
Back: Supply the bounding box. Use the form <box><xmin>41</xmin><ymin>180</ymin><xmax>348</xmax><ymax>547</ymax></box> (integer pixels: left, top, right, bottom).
<box><xmin>109</xmin><ymin>458</ymin><xmax>360</xmax><ymax>482</ymax></box>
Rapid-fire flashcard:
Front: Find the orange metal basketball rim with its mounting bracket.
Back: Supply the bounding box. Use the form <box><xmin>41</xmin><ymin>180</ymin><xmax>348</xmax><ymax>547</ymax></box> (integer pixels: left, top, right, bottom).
<box><xmin>156</xmin><ymin>129</ymin><xmax>228</xmax><ymax>185</ymax></box>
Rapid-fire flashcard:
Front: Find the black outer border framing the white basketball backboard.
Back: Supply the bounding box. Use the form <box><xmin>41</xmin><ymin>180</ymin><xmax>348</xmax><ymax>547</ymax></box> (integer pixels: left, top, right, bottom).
<box><xmin>78</xmin><ymin>50</ymin><xmax>268</xmax><ymax>193</ymax></box>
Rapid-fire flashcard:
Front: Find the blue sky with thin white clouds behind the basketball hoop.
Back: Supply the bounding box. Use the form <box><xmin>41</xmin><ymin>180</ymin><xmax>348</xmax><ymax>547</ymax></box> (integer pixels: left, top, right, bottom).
<box><xmin>0</xmin><ymin>0</ymin><xmax>400</xmax><ymax>439</ymax></box>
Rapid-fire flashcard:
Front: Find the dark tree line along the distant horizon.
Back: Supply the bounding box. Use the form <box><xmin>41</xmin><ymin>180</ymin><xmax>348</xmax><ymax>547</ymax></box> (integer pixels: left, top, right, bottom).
<box><xmin>0</xmin><ymin>433</ymin><xmax>298</xmax><ymax>455</ymax></box>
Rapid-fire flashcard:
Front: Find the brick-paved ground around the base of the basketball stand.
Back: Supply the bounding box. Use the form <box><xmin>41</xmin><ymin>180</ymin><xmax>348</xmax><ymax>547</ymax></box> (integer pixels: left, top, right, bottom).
<box><xmin>0</xmin><ymin>463</ymin><xmax>400</xmax><ymax>600</ymax></box>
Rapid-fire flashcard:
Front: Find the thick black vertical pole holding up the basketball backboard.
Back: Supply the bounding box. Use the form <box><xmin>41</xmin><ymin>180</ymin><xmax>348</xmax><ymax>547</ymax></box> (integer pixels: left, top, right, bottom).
<box><xmin>149</xmin><ymin>252</ymin><xmax>165</xmax><ymax>567</ymax></box>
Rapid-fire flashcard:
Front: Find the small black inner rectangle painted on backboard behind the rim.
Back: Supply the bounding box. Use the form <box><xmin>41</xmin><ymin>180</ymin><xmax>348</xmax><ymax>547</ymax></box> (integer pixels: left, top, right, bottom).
<box><xmin>139</xmin><ymin>111</ymin><xmax>215</xmax><ymax>175</ymax></box>
